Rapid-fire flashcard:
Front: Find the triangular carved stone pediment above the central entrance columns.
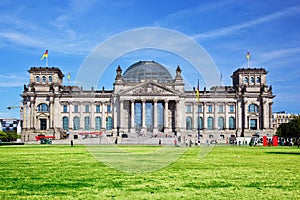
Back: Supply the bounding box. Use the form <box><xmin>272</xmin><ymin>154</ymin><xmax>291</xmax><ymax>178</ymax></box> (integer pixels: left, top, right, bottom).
<box><xmin>119</xmin><ymin>82</ymin><xmax>178</xmax><ymax>96</ymax></box>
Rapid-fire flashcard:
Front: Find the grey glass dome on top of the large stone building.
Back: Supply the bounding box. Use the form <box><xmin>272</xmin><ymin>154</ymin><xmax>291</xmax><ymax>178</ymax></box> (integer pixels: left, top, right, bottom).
<box><xmin>123</xmin><ymin>61</ymin><xmax>172</xmax><ymax>82</ymax></box>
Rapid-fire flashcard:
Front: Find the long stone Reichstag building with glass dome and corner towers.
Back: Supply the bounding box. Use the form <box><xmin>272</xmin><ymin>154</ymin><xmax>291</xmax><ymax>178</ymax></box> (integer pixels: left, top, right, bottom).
<box><xmin>21</xmin><ymin>61</ymin><xmax>274</xmax><ymax>141</ymax></box>
